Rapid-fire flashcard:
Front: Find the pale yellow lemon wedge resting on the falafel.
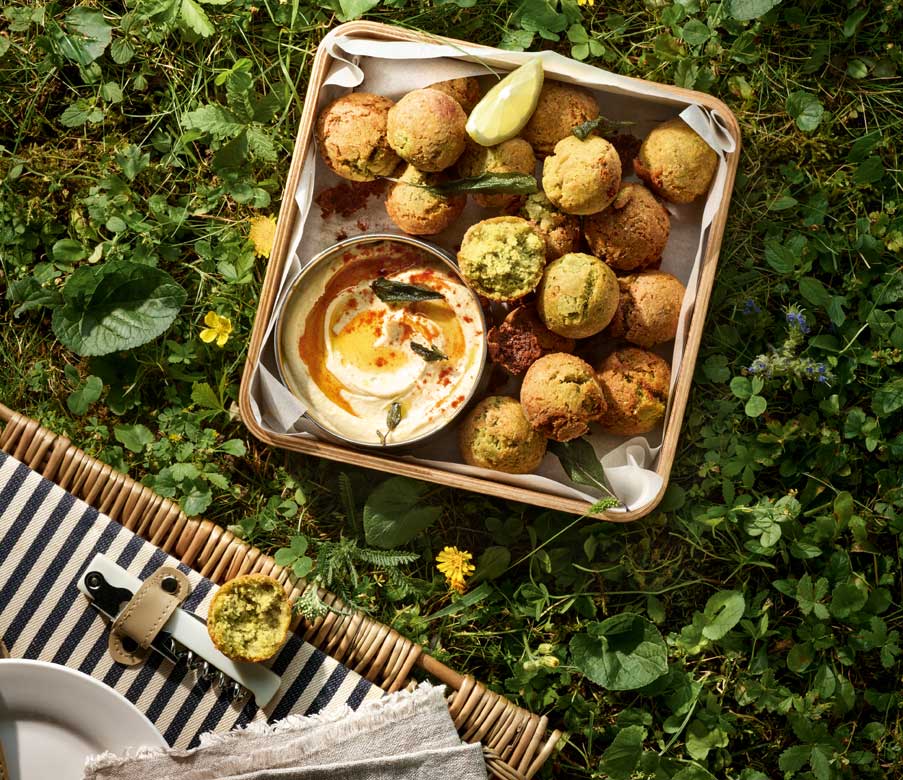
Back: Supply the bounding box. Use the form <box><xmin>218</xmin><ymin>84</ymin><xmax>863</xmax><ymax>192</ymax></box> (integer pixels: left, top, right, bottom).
<box><xmin>466</xmin><ymin>57</ymin><xmax>543</xmax><ymax>146</ymax></box>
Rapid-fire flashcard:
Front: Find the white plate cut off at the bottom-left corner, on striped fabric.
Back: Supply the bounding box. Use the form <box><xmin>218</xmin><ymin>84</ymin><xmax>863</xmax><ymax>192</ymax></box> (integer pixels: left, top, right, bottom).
<box><xmin>0</xmin><ymin>659</ymin><xmax>166</xmax><ymax>780</ymax></box>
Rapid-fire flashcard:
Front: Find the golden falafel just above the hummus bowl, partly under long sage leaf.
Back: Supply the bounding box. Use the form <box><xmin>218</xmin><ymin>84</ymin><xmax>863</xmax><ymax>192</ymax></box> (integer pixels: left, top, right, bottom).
<box><xmin>386</xmin><ymin>165</ymin><xmax>467</xmax><ymax>236</ymax></box>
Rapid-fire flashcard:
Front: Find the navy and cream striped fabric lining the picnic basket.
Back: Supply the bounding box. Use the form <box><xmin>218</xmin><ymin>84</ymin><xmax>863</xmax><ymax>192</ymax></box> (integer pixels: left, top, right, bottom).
<box><xmin>0</xmin><ymin>452</ymin><xmax>382</xmax><ymax>748</ymax></box>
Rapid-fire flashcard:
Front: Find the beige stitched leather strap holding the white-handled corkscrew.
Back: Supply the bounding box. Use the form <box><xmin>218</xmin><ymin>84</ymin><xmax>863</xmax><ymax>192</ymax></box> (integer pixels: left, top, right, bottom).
<box><xmin>108</xmin><ymin>566</ymin><xmax>191</xmax><ymax>666</ymax></box>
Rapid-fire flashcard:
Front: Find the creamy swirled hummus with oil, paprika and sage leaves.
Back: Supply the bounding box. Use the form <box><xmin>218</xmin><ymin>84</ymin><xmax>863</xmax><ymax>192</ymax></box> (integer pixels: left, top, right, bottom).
<box><xmin>281</xmin><ymin>240</ymin><xmax>485</xmax><ymax>444</ymax></box>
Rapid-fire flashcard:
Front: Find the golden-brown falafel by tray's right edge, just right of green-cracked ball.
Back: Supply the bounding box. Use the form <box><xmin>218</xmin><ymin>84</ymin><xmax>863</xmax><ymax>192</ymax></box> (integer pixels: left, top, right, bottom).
<box><xmin>607</xmin><ymin>271</ymin><xmax>687</xmax><ymax>349</ymax></box>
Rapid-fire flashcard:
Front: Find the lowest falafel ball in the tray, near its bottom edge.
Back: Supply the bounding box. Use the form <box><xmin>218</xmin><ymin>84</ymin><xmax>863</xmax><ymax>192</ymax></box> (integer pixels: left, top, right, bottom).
<box><xmin>458</xmin><ymin>395</ymin><xmax>546</xmax><ymax>474</ymax></box>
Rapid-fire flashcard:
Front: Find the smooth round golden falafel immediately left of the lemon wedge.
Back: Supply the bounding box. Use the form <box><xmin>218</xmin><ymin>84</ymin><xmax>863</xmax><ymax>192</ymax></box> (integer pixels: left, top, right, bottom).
<box><xmin>386</xmin><ymin>89</ymin><xmax>467</xmax><ymax>173</ymax></box>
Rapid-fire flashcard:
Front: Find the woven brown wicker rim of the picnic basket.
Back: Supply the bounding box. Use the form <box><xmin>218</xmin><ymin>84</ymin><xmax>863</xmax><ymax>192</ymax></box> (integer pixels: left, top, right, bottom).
<box><xmin>0</xmin><ymin>404</ymin><xmax>561</xmax><ymax>780</ymax></box>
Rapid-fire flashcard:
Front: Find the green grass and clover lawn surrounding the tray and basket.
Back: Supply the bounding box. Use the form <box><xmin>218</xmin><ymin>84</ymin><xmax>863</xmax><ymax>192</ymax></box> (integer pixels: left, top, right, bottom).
<box><xmin>0</xmin><ymin>0</ymin><xmax>903</xmax><ymax>780</ymax></box>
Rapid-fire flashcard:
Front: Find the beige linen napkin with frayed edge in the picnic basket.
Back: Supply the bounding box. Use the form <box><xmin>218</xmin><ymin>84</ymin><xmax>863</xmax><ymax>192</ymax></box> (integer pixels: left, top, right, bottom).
<box><xmin>84</xmin><ymin>683</ymin><xmax>487</xmax><ymax>780</ymax></box>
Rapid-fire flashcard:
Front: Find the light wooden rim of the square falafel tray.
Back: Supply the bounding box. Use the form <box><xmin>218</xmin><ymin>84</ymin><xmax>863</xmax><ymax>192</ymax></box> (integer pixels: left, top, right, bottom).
<box><xmin>239</xmin><ymin>22</ymin><xmax>740</xmax><ymax>522</ymax></box>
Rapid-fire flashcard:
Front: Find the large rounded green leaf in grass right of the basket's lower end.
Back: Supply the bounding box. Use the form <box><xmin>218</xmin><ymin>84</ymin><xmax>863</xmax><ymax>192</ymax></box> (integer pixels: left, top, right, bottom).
<box><xmin>570</xmin><ymin>612</ymin><xmax>668</xmax><ymax>691</ymax></box>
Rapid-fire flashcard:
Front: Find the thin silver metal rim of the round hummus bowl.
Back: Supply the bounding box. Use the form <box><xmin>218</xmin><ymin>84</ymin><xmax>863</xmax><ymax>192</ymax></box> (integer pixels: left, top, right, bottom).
<box><xmin>275</xmin><ymin>233</ymin><xmax>487</xmax><ymax>450</ymax></box>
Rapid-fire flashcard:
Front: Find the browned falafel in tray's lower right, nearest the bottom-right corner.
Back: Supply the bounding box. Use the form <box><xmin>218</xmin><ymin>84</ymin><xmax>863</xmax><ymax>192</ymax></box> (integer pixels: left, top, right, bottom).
<box><xmin>596</xmin><ymin>347</ymin><xmax>671</xmax><ymax>436</ymax></box>
